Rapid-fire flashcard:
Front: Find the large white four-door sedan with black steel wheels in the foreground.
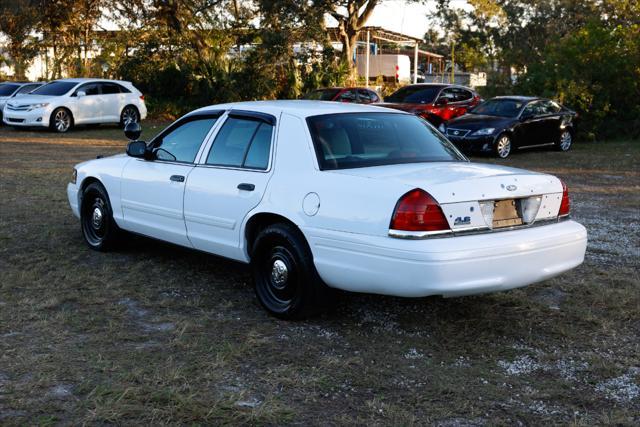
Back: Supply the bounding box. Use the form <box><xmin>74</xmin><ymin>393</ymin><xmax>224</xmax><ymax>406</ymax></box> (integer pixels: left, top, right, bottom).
<box><xmin>67</xmin><ymin>101</ymin><xmax>587</xmax><ymax>318</ymax></box>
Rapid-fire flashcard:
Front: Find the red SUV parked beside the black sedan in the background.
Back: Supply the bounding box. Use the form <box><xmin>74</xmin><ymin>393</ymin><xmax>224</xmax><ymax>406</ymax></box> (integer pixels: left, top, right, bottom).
<box><xmin>379</xmin><ymin>83</ymin><xmax>482</xmax><ymax>126</ymax></box>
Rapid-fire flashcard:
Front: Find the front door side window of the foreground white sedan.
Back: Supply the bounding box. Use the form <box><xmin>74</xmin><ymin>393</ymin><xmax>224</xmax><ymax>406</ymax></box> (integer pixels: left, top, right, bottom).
<box><xmin>153</xmin><ymin>117</ymin><xmax>217</xmax><ymax>163</ymax></box>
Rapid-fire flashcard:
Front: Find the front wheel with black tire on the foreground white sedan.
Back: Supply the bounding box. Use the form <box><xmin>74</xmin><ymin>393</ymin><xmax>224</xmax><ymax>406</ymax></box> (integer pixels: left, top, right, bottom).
<box><xmin>80</xmin><ymin>182</ymin><xmax>120</xmax><ymax>252</ymax></box>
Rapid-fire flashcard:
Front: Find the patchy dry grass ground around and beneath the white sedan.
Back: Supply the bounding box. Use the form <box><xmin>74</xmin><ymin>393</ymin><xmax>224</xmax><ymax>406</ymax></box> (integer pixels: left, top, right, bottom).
<box><xmin>0</xmin><ymin>124</ymin><xmax>640</xmax><ymax>426</ymax></box>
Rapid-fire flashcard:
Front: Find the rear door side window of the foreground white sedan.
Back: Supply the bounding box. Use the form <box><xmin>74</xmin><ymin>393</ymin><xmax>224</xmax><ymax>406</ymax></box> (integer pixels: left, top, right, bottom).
<box><xmin>206</xmin><ymin>117</ymin><xmax>273</xmax><ymax>170</ymax></box>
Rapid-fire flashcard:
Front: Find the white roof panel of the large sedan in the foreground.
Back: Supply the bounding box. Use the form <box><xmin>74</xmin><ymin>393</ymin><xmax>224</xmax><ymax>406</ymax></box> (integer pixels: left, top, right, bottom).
<box><xmin>193</xmin><ymin>100</ymin><xmax>408</xmax><ymax>118</ymax></box>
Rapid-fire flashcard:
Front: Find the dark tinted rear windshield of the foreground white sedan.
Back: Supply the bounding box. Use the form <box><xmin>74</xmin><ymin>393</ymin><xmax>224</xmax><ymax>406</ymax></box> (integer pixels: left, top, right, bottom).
<box><xmin>307</xmin><ymin>113</ymin><xmax>466</xmax><ymax>170</ymax></box>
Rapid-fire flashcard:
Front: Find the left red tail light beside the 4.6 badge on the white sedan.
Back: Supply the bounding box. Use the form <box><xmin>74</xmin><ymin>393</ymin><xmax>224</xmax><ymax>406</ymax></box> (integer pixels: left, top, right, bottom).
<box><xmin>390</xmin><ymin>189</ymin><xmax>449</xmax><ymax>231</ymax></box>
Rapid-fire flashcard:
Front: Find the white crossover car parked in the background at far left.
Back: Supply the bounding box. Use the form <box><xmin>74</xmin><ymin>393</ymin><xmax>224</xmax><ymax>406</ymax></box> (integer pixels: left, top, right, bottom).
<box><xmin>2</xmin><ymin>79</ymin><xmax>147</xmax><ymax>132</ymax></box>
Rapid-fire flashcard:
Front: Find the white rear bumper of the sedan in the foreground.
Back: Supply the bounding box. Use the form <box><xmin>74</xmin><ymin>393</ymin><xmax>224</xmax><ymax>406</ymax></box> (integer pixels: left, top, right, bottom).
<box><xmin>303</xmin><ymin>221</ymin><xmax>587</xmax><ymax>297</ymax></box>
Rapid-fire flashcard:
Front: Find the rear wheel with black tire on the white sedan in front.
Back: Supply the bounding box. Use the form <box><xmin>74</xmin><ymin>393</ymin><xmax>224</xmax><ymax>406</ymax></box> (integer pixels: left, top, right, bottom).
<box><xmin>251</xmin><ymin>223</ymin><xmax>334</xmax><ymax>320</ymax></box>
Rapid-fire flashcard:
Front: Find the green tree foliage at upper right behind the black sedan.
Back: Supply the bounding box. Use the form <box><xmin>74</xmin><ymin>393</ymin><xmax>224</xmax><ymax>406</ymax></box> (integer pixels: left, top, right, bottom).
<box><xmin>432</xmin><ymin>0</ymin><xmax>640</xmax><ymax>138</ymax></box>
